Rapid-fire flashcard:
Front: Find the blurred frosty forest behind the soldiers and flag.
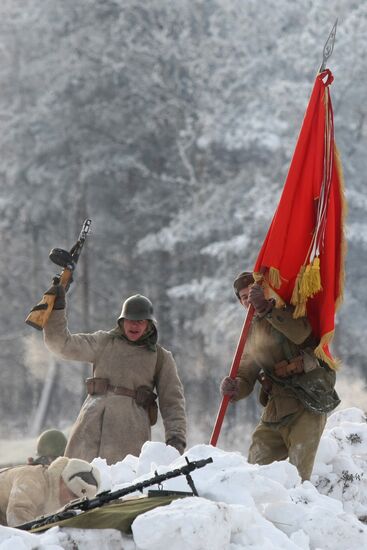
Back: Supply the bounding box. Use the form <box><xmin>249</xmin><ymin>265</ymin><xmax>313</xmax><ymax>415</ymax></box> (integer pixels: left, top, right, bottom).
<box><xmin>0</xmin><ymin>0</ymin><xmax>367</xmax><ymax>458</ymax></box>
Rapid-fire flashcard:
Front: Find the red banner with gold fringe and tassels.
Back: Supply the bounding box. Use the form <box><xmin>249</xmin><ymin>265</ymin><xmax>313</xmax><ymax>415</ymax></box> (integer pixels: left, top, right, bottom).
<box><xmin>254</xmin><ymin>70</ymin><xmax>345</xmax><ymax>367</ymax></box>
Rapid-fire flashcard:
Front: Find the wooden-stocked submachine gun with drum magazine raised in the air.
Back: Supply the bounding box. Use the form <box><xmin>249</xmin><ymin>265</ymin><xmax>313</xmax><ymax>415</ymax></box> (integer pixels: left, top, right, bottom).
<box><xmin>25</xmin><ymin>219</ymin><xmax>92</xmax><ymax>330</ymax></box>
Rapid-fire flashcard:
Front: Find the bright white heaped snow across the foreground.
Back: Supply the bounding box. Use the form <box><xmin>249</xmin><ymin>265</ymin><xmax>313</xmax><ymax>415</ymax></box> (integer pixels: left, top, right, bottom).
<box><xmin>0</xmin><ymin>408</ymin><xmax>367</xmax><ymax>550</ymax></box>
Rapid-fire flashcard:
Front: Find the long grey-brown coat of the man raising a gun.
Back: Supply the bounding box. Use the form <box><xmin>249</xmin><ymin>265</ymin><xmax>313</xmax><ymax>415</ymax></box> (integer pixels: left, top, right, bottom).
<box><xmin>44</xmin><ymin>310</ymin><xmax>186</xmax><ymax>464</ymax></box>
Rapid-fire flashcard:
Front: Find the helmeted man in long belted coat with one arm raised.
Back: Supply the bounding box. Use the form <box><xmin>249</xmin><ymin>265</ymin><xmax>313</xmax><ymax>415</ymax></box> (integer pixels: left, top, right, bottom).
<box><xmin>44</xmin><ymin>285</ymin><xmax>186</xmax><ymax>464</ymax></box>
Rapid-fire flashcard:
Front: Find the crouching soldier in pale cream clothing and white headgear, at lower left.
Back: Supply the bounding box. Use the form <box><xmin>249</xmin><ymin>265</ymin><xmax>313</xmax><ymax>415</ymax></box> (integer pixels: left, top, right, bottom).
<box><xmin>0</xmin><ymin>457</ymin><xmax>100</xmax><ymax>527</ymax></box>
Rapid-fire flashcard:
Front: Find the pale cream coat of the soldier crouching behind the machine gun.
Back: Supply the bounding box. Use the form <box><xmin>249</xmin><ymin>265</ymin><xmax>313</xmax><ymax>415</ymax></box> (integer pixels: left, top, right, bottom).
<box><xmin>0</xmin><ymin>458</ymin><xmax>68</xmax><ymax>527</ymax></box>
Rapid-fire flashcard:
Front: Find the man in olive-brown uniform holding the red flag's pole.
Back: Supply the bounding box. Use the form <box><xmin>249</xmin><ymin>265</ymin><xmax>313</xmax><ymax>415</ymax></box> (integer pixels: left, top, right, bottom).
<box><xmin>221</xmin><ymin>272</ymin><xmax>340</xmax><ymax>480</ymax></box>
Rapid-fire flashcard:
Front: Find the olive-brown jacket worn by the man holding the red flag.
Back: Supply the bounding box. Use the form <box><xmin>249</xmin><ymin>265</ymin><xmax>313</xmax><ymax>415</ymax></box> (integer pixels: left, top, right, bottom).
<box><xmin>234</xmin><ymin>306</ymin><xmax>340</xmax><ymax>423</ymax></box>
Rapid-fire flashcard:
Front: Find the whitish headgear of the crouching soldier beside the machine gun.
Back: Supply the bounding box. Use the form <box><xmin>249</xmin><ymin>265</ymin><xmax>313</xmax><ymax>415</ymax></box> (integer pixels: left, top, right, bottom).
<box><xmin>61</xmin><ymin>458</ymin><xmax>101</xmax><ymax>498</ymax></box>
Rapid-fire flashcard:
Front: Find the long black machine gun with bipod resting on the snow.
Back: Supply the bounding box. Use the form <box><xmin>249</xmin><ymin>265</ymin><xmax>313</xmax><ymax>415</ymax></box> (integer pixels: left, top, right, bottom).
<box><xmin>16</xmin><ymin>457</ymin><xmax>213</xmax><ymax>531</ymax></box>
